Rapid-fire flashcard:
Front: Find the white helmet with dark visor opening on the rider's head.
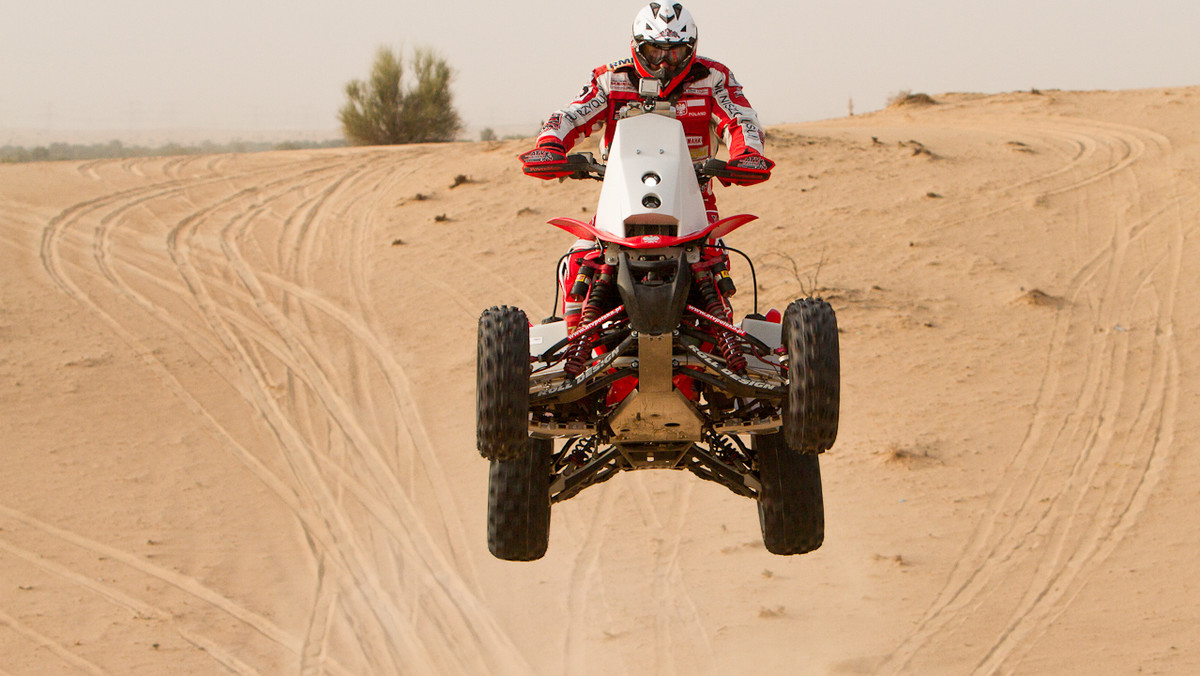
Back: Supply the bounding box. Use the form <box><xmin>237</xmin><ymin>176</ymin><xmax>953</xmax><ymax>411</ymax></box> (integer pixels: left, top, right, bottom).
<box><xmin>630</xmin><ymin>2</ymin><xmax>700</xmax><ymax>94</ymax></box>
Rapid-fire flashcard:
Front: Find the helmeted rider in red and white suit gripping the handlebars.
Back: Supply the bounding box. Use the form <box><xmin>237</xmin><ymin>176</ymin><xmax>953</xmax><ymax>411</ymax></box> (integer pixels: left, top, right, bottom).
<box><xmin>521</xmin><ymin>2</ymin><xmax>775</xmax><ymax>324</ymax></box>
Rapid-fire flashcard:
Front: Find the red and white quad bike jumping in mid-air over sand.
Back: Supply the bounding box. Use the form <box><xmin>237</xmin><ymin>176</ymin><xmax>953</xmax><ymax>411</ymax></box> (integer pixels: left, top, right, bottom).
<box><xmin>476</xmin><ymin>102</ymin><xmax>840</xmax><ymax>561</ymax></box>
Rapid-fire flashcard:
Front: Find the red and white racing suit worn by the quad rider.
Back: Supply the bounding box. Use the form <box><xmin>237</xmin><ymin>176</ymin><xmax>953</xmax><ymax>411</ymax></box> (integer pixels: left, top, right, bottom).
<box><xmin>536</xmin><ymin>56</ymin><xmax>763</xmax><ymax>330</ymax></box>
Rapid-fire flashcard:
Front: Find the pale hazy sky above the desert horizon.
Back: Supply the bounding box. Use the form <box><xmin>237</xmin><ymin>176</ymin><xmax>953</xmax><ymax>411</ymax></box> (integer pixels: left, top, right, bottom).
<box><xmin>0</xmin><ymin>0</ymin><xmax>1200</xmax><ymax>145</ymax></box>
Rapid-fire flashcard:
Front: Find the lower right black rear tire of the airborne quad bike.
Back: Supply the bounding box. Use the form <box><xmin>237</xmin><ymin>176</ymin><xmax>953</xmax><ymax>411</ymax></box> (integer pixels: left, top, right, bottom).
<box><xmin>750</xmin><ymin>433</ymin><xmax>824</xmax><ymax>556</ymax></box>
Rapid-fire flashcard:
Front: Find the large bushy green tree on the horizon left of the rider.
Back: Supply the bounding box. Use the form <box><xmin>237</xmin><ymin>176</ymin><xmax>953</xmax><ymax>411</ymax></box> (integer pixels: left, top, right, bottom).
<box><xmin>337</xmin><ymin>47</ymin><xmax>462</xmax><ymax>145</ymax></box>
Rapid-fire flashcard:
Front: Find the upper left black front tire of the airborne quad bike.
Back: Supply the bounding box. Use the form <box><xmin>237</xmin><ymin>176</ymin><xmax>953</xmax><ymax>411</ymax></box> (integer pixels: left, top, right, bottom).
<box><xmin>475</xmin><ymin>305</ymin><xmax>529</xmax><ymax>460</ymax></box>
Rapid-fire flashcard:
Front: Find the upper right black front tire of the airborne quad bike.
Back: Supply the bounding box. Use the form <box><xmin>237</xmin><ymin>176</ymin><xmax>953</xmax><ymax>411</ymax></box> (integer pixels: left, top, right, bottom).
<box><xmin>784</xmin><ymin>298</ymin><xmax>841</xmax><ymax>453</ymax></box>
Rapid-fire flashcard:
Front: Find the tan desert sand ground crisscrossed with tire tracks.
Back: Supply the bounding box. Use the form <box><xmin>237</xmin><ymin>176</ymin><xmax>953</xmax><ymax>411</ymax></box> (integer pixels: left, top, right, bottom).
<box><xmin>0</xmin><ymin>88</ymin><xmax>1200</xmax><ymax>676</ymax></box>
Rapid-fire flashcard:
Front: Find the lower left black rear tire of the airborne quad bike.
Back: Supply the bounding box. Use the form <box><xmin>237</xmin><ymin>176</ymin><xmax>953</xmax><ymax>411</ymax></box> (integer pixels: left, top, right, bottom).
<box><xmin>487</xmin><ymin>437</ymin><xmax>554</xmax><ymax>561</ymax></box>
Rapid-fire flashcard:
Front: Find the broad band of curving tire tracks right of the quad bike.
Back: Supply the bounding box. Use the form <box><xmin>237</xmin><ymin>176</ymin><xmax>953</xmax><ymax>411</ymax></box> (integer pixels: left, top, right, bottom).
<box><xmin>881</xmin><ymin>118</ymin><xmax>1194</xmax><ymax>674</ymax></box>
